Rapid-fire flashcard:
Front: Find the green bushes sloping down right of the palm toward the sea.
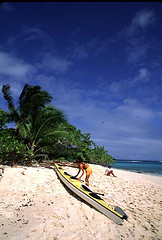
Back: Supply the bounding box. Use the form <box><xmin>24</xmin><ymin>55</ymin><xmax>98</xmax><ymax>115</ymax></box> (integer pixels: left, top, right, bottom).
<box><xmin>49</xmin><ymin>122</ymin><xmax>114</xmax><ymax>164</ymax></box>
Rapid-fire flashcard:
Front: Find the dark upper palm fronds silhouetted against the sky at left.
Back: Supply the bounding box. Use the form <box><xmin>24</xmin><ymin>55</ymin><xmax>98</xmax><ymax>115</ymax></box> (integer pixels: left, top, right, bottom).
<box><xmin>2</xmin><ymin>84</ymin><xmax>52</xmax><ymax>127</ymax></box>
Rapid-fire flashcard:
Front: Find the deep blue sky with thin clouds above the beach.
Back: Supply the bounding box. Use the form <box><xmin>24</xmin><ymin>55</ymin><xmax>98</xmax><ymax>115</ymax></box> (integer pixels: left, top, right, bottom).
<box><xmin>0</xmin><ymin>2</ymin><xmax>162</xmax><ymax>160</ymax></box>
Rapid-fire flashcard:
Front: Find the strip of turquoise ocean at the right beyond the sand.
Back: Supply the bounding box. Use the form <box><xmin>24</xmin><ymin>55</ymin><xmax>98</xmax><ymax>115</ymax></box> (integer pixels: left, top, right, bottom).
<box><xmin>112</xmin><ymin>160</ymin><xmax>162</xmax><ymax>176</ymax></box>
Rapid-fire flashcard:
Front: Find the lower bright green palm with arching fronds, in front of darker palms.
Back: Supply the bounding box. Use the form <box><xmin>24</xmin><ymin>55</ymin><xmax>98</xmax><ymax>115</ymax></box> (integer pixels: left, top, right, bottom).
<box><xmin>23</xmin><ymin>106</ymin><xmax>68</xmax><ymax>153</ymax></box>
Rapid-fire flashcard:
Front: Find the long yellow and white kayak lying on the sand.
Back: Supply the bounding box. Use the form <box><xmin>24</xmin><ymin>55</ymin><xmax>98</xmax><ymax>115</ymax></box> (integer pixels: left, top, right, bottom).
<box><xmin>54</xmin><ymin>163</ymin><xmax>128</xmax><ymax>224</ymax></box>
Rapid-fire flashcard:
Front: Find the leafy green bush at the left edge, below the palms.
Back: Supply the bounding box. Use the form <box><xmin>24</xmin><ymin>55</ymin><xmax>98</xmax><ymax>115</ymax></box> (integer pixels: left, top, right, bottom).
<box><xmin>0</xmin><ymin>129</ymin><xmax>32</xmax><ymax>166</ymax></box>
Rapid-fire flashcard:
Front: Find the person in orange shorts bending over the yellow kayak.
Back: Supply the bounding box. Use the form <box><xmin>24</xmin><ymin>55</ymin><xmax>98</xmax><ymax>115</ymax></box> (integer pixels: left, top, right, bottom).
<box><xmin>74</xmin><ymin>159</ymin><xmax>92</xmax><ymax>187</ymax></box>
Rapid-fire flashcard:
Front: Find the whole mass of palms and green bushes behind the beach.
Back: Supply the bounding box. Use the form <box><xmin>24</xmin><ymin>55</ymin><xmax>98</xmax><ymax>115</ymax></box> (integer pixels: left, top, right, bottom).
<box><xmin>0</xmin><ymin>84</ymin><xmax>113</xmax><ymax>165</ymax></box>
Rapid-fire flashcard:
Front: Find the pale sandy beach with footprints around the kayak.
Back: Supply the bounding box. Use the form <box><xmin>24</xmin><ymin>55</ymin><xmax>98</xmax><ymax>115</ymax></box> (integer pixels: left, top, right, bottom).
<box><xmin>0</xmin><ymin>165</ymin><xmax>162</xmax><ymax>240</ymax></box>
